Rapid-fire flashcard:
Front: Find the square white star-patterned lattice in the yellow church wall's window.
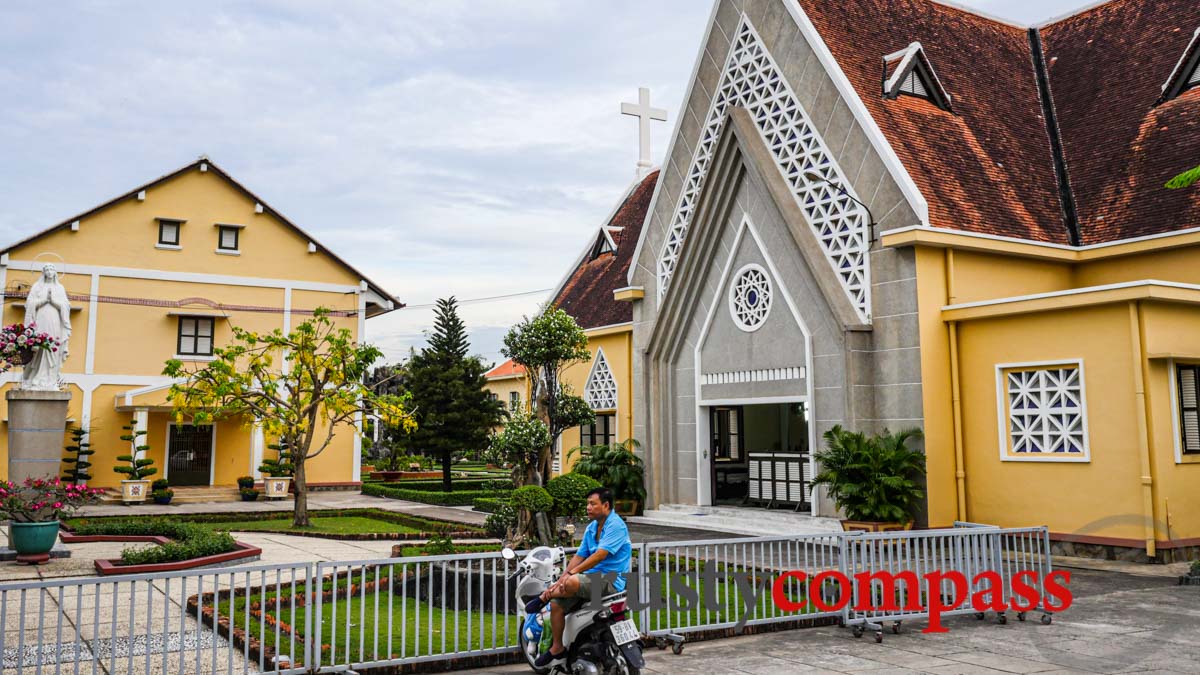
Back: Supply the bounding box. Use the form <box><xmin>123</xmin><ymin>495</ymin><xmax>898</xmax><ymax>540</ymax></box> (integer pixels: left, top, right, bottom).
<box><xmin>1004</xmin><ymin>366</ymin><xmax>1087</xmax><ymax>459</ymax></box>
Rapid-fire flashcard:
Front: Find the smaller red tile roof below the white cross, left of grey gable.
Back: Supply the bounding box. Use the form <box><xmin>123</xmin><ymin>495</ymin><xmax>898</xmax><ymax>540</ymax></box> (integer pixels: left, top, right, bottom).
<box><xmin>554</xmin><ymin>171</ymin><xmax>659</xmax><ymax>328</ymax></box>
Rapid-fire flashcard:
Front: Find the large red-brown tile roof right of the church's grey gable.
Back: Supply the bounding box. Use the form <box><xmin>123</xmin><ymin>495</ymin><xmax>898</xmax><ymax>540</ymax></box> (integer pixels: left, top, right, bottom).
<box><xmin>793</xmin><ymin>0</ymin><xmax>1200</xmax><ymax>244</ymax></box>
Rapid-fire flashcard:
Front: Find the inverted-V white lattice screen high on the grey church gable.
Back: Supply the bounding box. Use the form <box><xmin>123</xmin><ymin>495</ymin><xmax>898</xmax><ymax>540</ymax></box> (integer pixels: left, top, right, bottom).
<box><xmin>658</xmin><ymin>17</ymin><xmax>870</xmax><ymax>318</ymax></box>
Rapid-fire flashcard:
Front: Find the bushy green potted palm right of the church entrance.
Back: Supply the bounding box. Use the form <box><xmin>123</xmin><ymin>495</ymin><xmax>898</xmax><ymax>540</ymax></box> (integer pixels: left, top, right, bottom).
<box><xmin>812</xmin><ymin>426</ymin><xmax>925</xmax><ymax>532</ymax></box>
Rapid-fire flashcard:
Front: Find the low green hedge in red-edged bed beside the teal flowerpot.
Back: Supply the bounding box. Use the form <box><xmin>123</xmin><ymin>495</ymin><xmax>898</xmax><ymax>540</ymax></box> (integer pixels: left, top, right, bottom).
<box><xmin>74</xmin><ymin>518</ymin><xmax>238</xmax><ymax>565</ymax></box>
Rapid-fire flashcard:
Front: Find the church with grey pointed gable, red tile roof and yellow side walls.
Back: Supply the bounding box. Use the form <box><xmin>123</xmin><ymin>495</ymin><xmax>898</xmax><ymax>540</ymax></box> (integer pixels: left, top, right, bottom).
<box><xmin>628</xmin><ymin>0</ymin><xmax>1200</xmax><ymax>561</ymax></box>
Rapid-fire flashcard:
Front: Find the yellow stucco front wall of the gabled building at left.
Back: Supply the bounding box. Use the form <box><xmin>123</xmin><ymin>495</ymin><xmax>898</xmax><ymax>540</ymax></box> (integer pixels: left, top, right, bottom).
<box><xmin>0</xmin><ymin>163</ymin><xmax>376</xmax><ymax>486</ymax></box>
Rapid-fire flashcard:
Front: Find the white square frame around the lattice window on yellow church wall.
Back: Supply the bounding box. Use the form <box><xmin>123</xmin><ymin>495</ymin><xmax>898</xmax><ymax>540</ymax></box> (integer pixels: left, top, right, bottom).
<box><xmin>996</xmin><ymin>359</ymin><xmax>1092</xmax><ymax>462</ymax></box>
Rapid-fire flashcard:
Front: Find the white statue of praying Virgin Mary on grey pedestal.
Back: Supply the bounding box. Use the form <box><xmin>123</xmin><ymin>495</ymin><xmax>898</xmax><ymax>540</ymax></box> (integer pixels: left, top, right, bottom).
<box><xmin>20</xmin><ymin>264</ymin><xmax>71</xmax><ymax>392</ymax></box>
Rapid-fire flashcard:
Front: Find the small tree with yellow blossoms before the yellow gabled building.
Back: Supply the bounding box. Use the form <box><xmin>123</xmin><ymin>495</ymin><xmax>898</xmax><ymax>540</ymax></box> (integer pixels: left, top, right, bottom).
<box><xmin>163</xmin><ymin>307</ymin><xmax>416</xmax><ymax>527</ymax></box>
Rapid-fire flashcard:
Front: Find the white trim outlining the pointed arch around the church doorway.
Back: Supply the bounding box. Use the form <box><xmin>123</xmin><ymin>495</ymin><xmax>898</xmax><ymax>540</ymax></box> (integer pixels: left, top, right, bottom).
<box><xmin>692</xmin><ymin>214</ymin><xmax>821</xmax><ymax>515</ymax></box>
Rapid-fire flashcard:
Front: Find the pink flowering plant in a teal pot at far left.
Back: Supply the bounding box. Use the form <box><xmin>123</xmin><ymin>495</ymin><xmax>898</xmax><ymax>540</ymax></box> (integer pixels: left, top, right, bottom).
<box><xmin>0</xmin><ymin>478</ymin><xmax>103</xmax><ymax>565</ymax></box>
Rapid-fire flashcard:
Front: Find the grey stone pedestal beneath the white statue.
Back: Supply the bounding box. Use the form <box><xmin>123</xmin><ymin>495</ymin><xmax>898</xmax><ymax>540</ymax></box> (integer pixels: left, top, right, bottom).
<box><xmin>5</xmin><ymin>389</ymin><xmax>71</xmax><ymax>483</ymax></box>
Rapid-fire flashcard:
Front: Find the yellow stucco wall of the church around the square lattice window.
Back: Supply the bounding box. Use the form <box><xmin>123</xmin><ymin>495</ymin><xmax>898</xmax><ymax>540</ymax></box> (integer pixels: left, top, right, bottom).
<box><xmin>916</xmin><ymin>236</ymin><xmax>1200</xmax><ymax>545</ymax></box>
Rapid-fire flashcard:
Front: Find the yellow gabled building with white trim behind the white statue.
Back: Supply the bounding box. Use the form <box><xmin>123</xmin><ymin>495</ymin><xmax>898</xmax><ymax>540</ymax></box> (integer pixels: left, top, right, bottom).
<box><xmin>0</xmin><ymin>157</ymin><xmax>403</xmax><ymax>488</ymax></box>
